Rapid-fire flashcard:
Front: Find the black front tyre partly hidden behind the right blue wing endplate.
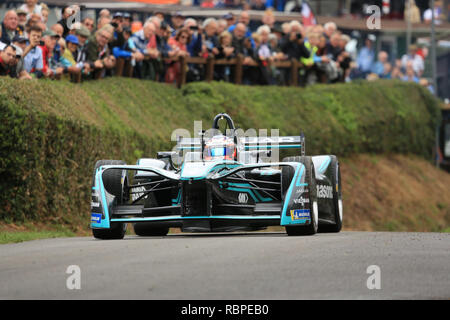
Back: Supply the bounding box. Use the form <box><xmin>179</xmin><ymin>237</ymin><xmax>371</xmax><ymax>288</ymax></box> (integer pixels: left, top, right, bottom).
<box><xmin>281</xmin><ymin>156</ymin><xmax>319</xmax><ymax>236</ymax></box>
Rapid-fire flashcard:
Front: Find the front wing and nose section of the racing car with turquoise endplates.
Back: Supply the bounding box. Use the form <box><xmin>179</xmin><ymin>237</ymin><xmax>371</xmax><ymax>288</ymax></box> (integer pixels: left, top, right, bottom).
<box><xmin>91</xmin><ymin>162</ymin><xmax>311</xmax><ymax>231</ymax></box>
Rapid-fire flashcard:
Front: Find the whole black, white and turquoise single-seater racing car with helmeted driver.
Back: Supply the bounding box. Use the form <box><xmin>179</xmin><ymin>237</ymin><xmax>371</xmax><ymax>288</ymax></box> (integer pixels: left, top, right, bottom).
<box><xmin>91</xmin><ymin>114</ymin><xmax>343</xmax><ymax>239</ymax></box>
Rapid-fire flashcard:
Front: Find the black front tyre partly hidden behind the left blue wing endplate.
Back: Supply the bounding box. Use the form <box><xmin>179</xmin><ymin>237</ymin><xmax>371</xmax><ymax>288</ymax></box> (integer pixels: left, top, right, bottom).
<box><xmin>92</xmin><ymin>160</ymin><xmax>127</xmax><ymax>240</ymax></box>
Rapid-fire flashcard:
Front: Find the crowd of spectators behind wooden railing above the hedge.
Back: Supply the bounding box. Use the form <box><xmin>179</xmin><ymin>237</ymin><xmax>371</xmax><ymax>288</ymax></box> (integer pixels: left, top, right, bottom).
<box><xmin>0</xmin><ymin>0</ymin><xmax>436</xmax><ymax>91</ymax></box>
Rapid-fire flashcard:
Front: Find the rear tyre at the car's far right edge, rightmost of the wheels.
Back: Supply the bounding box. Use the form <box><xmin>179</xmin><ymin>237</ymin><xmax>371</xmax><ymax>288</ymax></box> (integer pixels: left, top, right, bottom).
<box><xmin>319</xmin><ymin>156</ymin><xmax>343</xmax><ymax>232</ymax></box>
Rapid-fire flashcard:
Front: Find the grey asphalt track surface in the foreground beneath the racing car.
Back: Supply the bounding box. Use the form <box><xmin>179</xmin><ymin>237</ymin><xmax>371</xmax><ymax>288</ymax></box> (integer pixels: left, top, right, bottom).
<box><xmin>0</xmin><ymin>232</ymin><xmax>450</xmax><ymax>299</ymax></box>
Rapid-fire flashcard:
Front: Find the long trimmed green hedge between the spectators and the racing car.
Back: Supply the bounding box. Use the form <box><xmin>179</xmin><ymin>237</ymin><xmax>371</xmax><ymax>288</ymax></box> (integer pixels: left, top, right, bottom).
<box><xmin>0</xmin><ymin>78</ymin><xmax>440</xmax><ymax>225</ymax></box>
